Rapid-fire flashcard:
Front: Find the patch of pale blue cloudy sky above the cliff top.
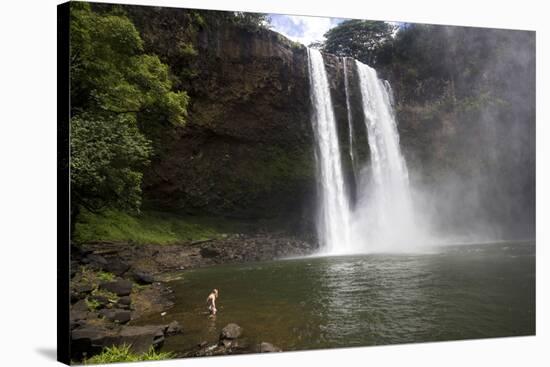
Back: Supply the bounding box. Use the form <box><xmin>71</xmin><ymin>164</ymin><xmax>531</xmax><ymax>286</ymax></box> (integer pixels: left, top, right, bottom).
<box><xmin>269</xmin><ymin>14</ymin><xmax>345</xmax><ymax>46</ymax></box>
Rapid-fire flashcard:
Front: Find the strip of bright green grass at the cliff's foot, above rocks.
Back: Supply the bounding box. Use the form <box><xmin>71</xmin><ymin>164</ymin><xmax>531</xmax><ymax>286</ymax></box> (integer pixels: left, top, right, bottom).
<box><xmin>73</xmin><ymin>210</ymin><xmax>244</xmax><ymax>245</ymax></box>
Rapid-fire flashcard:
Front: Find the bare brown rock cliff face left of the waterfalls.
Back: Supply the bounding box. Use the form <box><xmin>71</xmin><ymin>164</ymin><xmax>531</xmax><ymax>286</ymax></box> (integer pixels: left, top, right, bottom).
<box><xmin>144</xmin><ymin>26</ymin><xmax>322</xmax><ymax>230</ymax></box>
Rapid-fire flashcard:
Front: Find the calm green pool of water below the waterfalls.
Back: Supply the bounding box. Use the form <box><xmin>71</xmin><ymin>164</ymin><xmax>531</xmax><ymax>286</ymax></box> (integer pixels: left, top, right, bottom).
<box><xmin>137</xmin><ymin>242</ymin><xmax>535</xmax><ymax>351</ymax></box>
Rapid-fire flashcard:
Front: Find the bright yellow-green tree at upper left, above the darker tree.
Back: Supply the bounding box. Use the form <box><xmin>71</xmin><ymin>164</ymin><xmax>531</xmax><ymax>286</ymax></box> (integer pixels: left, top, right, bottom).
<box><xmin>71</xmin><ymin>2</ymin><xmax>189</xmax><ymax>125</ymax></box>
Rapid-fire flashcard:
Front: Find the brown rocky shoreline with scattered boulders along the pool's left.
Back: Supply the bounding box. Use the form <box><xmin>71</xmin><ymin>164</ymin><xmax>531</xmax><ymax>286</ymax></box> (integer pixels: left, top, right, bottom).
<box><xmin>70</xmin><ymin>234</ymin><xmax>316</xmax><ymax>361</ymax></box>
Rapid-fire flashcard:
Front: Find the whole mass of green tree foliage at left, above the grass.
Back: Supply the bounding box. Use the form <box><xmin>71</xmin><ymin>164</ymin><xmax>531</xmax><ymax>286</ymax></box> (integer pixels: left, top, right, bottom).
<box><xmin>70</xmin><ymin>2</ymin><xmax>189</xmax><ymax>228</ymax></box>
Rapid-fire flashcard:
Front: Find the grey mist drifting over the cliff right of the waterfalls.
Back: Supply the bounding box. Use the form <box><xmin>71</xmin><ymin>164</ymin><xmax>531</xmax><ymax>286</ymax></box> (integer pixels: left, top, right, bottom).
<box><xmin>397</xmin><ymin>26</ymin><xmax>535</xmax><ymax>244</ymax></box>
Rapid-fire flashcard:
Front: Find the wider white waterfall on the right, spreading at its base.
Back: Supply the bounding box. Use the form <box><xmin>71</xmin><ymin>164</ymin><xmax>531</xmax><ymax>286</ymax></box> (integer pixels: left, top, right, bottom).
<box><xmin>354</xmin><ymin>60</ymin><xmax>419</xmax><ymax>250</ymax></box>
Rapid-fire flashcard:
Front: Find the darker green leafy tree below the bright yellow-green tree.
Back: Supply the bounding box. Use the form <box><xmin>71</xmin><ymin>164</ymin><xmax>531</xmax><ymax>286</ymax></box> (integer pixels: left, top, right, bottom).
<box><xmin>71</xmin><ymin>114</ymin><xmax>151</xmax><ymax>212</ymax></box>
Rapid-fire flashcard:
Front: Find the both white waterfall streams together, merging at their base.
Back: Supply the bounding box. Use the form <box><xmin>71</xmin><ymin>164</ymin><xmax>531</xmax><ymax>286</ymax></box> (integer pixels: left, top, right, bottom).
<box><xmin>308</xmin><ymin>49</ymin><xmax>419</xmax><ymax>255</ymax></box>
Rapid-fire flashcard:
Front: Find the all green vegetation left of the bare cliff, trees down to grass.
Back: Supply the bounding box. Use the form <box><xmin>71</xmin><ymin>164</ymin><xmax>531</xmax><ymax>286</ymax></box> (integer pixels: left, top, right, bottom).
<box><xmin>70</xmin><ymin>2</ymin><xmax>278</xmax><ymax>243</ymax></box>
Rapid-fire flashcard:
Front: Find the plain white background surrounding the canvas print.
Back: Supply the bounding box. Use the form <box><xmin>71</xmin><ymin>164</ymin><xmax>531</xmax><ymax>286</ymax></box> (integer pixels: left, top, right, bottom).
<box><xmin>0</xmin><ymin>0</ymin><xmax>550</xmax><ymax>367</ymax></box>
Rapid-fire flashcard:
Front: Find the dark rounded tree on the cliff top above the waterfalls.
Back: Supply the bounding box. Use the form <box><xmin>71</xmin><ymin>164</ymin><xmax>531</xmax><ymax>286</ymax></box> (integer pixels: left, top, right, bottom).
<box><xmin>322</xmin><ymin>19</ymin><xmax>395</xmax><ymax>65</ymax></box>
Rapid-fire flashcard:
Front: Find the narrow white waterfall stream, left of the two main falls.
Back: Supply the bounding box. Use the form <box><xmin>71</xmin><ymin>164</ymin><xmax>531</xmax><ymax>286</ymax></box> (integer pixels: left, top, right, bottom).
<box><xmin>308</xmin><ymin>49</ymin><xmax>351</xmax><ymax>253</ymax></box>
